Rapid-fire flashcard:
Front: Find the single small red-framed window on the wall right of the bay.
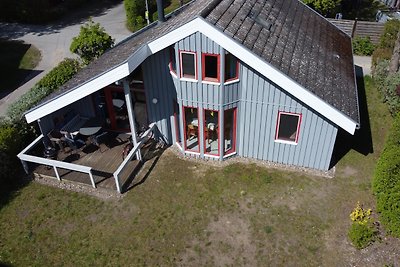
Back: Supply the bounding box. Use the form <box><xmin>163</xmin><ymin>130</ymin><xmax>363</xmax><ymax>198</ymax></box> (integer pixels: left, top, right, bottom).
<box><xmin>275</xmin><ymin>111</ymin><xmax>301</xmax><ymax>144</ymax></box>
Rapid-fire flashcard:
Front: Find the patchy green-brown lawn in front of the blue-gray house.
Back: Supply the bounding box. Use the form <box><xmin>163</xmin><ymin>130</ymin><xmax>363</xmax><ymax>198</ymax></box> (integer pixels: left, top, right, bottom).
<box><xmin>0</xmin><ymin>75</ymin><xmax>400</xmax><ymax>266</ymax></box>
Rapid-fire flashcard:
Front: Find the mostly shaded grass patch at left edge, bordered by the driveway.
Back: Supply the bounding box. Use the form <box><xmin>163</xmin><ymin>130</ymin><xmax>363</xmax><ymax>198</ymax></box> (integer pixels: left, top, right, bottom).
<box><xmin>0</xmin><ymin>39</ymin><xmax>41</xmax><ymax>92</ymax></box>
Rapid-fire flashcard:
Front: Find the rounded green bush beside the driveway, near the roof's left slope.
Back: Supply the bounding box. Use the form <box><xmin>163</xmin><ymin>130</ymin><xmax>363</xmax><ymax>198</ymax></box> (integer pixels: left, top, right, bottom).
<box><xmin>69</xmin><ymin>19</ymin><xmax>114</xmax><ymax>64</ymax></box>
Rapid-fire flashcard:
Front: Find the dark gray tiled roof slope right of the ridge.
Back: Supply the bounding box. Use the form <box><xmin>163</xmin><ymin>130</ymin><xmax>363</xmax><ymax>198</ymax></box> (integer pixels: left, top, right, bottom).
<box><xmin>202</xmin><ymin>0</ymin><xmax>359</xmax><ymax>123</ymax></box>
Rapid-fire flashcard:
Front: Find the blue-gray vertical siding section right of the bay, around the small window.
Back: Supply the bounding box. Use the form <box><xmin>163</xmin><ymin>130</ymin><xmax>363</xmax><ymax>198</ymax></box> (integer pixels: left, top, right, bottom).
<box><xmin>238</xmin><ymin>65</ymin><xmax>337</xmax><ymax>170</ymax></box>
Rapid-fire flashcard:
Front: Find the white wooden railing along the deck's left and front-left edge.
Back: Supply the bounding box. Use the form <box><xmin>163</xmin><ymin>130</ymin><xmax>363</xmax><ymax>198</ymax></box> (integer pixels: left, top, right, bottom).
<box><xmin>17</xmin><ymin>134</ymin><xmax>96</xmax><ymax>188</ymax></box>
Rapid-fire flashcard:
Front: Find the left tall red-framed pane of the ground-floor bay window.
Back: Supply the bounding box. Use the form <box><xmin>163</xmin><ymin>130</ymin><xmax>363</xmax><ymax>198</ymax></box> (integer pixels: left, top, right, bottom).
<box><xmin>184</xmin><ymin>107</ymin><xmax>200</xmax><ymax>152</ymax></box>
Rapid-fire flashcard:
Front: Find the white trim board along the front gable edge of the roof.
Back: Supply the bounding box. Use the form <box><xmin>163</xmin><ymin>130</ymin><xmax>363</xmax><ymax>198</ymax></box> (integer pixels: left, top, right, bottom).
<box><xmin>26</xmin><ymin>17</ymin><xmax>357</xmax><ymax>134</ymax></box>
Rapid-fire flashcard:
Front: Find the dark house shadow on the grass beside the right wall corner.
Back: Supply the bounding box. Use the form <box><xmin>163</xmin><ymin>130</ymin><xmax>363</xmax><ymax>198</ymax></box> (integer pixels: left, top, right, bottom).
<box><xmin>329</xmin><ymin>66</ymin><xmax>374</xmax><ymax>168</ymax></box>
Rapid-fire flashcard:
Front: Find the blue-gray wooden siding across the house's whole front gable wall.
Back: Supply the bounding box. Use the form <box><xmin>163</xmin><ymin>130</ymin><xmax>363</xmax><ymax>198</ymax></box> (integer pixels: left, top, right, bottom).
<box><xmin>142</xmin><ymin>30</ymin><xmax>337</xmax><ymax>170</ymax></box>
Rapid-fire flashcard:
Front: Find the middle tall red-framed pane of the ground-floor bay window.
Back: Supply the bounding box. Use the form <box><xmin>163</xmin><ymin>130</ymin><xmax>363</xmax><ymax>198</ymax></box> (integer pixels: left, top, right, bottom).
<box><xmin>204</xmin><ymin>110</ymin><xmax>219</xmax><ymax>156</ymax></box>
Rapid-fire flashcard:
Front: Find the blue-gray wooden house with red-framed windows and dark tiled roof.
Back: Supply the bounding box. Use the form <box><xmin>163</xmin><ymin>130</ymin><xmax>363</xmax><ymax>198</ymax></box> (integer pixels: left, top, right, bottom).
<box><xmin>19</xmin><ymin>0</ymin><xmax>360</xmax><ymax>193</ymax></box>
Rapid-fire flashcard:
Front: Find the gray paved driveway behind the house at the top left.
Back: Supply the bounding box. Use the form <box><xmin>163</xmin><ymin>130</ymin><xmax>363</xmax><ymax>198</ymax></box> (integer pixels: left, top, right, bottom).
<box><xmin>0</xmin><ymin>3</ymin><xmax>131</xmax><ymax>116</ymax></box>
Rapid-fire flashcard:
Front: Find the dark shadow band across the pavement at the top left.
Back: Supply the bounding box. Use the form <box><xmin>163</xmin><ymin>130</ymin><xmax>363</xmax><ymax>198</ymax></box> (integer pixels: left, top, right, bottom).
<box><xmin>0</xmin><ymin>0</ymin><xmax>122</xmax><ymax>39</ymax></box>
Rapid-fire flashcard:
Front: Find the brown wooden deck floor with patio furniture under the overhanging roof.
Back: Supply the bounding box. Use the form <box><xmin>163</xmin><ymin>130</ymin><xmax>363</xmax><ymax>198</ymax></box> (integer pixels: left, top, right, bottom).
<box><xmin>33</xmin><ymin>136</ymin><xmax>145</xmax><ymax>193</ymax></box>
